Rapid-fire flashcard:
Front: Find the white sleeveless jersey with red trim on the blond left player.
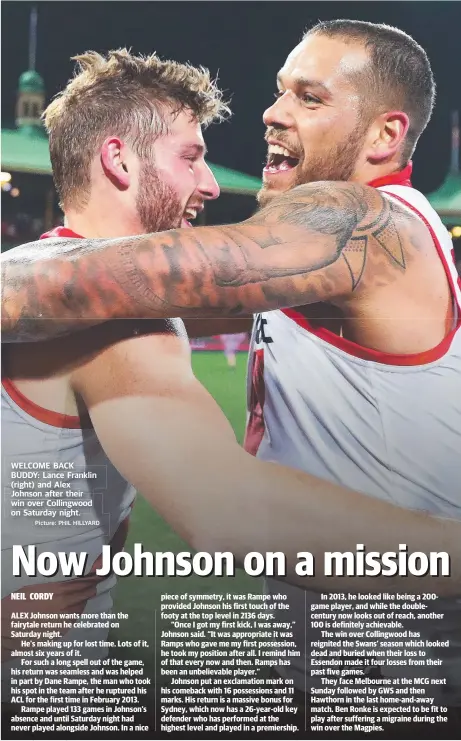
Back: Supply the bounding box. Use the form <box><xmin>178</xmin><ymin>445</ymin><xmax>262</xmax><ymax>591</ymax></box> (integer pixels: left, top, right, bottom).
<box><xmin>2</xmin><ymin>224</ymin><xmax>135</xmax><ymax>684</ymax></box>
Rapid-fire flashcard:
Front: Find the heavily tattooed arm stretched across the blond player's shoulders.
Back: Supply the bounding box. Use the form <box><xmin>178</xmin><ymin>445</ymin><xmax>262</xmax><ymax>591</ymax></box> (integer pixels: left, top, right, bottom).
<box><xmin>2</xmin><ymin>183</ymin><xmax>417</xmax><ymax>342</ymax></box>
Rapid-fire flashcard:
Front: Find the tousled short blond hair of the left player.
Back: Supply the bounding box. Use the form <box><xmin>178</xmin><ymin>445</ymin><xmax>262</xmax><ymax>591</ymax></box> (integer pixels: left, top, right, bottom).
<box><xmin>43</xmin><ymin>49</ymin><xmax>230</xmax><ymax>208</ymax></box>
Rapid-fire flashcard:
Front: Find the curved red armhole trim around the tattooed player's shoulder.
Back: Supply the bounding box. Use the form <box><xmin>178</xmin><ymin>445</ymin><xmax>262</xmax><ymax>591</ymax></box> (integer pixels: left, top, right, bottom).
<box><xmin>282</xmin><ymin>188</ymin><xmax>461</xmax><ymax>366</ymax></box>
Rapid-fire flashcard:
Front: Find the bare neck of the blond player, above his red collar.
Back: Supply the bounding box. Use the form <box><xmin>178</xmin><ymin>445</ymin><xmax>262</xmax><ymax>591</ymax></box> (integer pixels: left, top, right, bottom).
<box><xmin>64</xmin><ymin>203</ymin><xmax>144</xmax><ymax>239</ymax></box>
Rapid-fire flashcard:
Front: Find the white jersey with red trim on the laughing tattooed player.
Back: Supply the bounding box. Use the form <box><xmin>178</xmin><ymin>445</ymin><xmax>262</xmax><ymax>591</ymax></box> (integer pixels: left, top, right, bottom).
<box><xmin>245</xmin><ymin>167</ymin><xmax>461</xmax><ymax>705</ymax></box>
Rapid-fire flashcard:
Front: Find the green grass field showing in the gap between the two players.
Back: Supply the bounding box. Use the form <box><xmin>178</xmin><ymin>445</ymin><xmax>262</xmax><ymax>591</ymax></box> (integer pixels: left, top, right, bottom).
<box><xmin>108</xmin><ymin>351</ymin><xmax>261</xmax><ymax>676</ymax></box>
